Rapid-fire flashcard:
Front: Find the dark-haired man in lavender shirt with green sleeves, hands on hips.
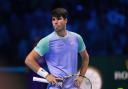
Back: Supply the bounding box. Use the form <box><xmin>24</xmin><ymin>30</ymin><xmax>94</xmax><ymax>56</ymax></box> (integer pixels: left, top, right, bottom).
<box><xmin>25</xmin><ymin>8</ymin><xmax>89</xmax><ymax>89</ymax></box>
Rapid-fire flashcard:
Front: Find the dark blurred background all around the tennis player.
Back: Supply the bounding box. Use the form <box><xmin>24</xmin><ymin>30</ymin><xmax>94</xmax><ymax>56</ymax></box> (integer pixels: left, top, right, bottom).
<box><xmin>0</xmin><ymin>0</ymin><xmax>128</xmax><ymax>89</ymax></box>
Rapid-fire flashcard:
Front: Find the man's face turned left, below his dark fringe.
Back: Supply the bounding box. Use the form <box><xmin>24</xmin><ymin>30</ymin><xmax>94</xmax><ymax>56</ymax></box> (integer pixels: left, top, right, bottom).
<box><xmin>52</xmin><ymin>16</ymin><xmax>67</xmax><ymax>32</ymax></box>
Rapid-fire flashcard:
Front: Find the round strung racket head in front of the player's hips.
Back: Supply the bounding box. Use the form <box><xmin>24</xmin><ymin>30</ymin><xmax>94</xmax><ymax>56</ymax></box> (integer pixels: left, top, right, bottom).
<box><xmin>61</xmin><ymin>74</ymin><xmax>92</xmax><ymax>89</ymax></box>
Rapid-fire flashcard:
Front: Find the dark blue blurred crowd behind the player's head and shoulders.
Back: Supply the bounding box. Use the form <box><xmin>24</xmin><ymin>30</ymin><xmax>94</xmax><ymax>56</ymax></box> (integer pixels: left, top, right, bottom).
<box><xmin>0</xmin><ymin>0</ymin><xmax>128</xmax><ymax>66</ymax></box>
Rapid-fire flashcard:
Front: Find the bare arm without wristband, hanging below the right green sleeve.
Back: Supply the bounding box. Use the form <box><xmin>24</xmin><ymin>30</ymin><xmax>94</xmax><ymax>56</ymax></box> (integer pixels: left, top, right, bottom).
<box><xmin>80</xmin><ymin>50</ymin><xmax>89</xmax><ymax>76</ymax></box>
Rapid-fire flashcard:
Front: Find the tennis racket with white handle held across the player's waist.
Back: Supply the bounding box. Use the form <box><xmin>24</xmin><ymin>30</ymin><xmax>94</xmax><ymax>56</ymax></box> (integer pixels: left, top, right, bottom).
<box><xmin>33</xmin><ymin>74</ymin><xmax>92</xmax><ymax>89</ymax></box>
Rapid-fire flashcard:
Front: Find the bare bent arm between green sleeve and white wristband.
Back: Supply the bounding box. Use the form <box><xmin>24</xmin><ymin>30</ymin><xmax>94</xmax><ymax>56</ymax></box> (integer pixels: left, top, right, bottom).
<box><xmin>25</xmin><ymin>50</ymin><xmax>41</xmax><ymax>72</ymax></box>
